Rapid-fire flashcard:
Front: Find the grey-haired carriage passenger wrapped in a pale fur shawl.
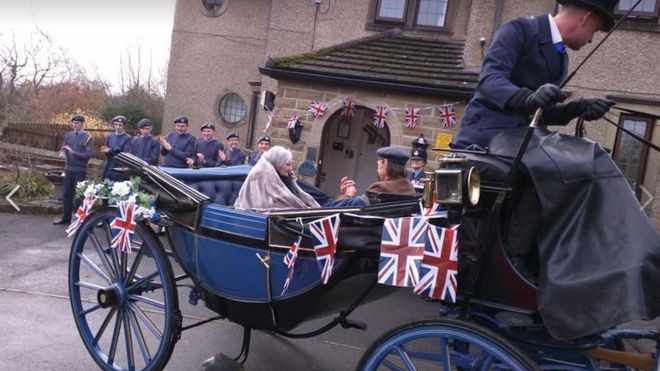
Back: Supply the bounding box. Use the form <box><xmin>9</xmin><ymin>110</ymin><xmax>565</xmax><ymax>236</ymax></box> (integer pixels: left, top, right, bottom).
<box><xmin>234</xmin><ymin>146</ymin><xmax>319</xmax><ymax>212</ymax></box>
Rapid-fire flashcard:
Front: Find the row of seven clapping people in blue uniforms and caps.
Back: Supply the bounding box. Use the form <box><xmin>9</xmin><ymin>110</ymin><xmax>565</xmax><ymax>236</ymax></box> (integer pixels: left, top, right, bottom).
<box><xmin>53</xmin><ymin>115</ymin><xmax>271</xmax><ymax>224</ymax></box>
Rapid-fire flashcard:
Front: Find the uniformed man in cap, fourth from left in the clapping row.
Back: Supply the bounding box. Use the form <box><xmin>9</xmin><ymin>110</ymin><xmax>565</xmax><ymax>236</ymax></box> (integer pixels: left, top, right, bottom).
<box><xmin>160</xmin><ymin>116</ymin><xmax>195</xmax><ymax>168</ymax></box>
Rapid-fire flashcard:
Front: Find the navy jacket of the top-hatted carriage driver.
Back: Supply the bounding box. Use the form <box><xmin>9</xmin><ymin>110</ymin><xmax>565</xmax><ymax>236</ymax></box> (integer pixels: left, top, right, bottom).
<box><xmin>452</xmin><ymin>14</ymin><xmax>568</xmax><ymax>148</ymax></box>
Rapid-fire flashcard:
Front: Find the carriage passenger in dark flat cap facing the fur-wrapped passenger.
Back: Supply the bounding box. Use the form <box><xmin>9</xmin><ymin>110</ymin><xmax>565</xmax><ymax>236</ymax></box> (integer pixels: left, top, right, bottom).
<box><xmin>324</xmin><ymin>147</ymin><xmax>416</xmax><ymax>207</ymax></box>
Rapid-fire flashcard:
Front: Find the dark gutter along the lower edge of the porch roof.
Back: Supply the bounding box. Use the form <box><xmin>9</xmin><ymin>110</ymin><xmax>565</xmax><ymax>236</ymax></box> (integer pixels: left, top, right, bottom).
<box><xmin>259</xmin><ymin>67</ymin><xmax>474</xmax><ymax>99</ymax></box>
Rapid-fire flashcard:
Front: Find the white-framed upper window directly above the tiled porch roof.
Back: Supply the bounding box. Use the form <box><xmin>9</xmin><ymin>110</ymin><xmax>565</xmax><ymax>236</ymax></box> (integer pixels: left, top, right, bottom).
<box><xmin>374</xmin><ymin>0</ymin><xmax>450</xmax><ymax>29</ymax></box>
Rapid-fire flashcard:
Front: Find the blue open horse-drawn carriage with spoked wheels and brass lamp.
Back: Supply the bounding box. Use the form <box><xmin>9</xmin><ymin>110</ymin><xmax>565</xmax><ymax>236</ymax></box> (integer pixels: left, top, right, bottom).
<box><xmin>69</xmin><ymin>127</ymin><xmax>660</xmax><ymax>370</ymax></box>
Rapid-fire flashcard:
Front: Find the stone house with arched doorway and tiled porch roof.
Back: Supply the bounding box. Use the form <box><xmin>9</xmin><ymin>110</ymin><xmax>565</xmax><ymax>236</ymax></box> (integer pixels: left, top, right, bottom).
<box><xmin>163</xmin><ymin>0</ymin><xmax>660</xmax><ymax>227</ymax></box>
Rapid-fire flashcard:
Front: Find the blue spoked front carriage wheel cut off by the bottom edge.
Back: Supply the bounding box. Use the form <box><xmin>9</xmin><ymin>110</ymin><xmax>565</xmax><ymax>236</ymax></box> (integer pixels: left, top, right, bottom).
<box><xmin>357</xmin><ymin>319</ymin><xmax>538</xmax><ymax>371</ymax></box>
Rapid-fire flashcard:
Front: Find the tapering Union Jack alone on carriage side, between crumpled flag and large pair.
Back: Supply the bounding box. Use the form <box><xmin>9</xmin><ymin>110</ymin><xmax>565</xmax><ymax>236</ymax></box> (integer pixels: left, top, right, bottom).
<box><xmin>309</xmin><ymin>214</ymin><xmax>339</xmax><ymax>284</ymax></box>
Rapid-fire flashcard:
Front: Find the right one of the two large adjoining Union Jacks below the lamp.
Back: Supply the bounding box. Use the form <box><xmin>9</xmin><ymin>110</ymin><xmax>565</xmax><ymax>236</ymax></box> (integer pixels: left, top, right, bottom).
<box><xmin>415</xmin><ymin>226</ymin><xmax>458</xmax><ymax>303</ymax></box>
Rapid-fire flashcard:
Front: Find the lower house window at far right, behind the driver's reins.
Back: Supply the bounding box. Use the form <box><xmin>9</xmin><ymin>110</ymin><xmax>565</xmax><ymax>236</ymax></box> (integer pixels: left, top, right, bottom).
<box><xmin>612</xmin><ymin>116</ymin><xmax>653</xmax><ymax>198</ymax></box>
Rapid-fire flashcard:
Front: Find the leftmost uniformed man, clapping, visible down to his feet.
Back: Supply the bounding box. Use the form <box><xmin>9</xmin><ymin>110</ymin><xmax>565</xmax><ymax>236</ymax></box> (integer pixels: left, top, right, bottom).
<box><xmin>53</xmin><ymin>115</ymin><xmax>94</xmax><ymax>224</ymax></box>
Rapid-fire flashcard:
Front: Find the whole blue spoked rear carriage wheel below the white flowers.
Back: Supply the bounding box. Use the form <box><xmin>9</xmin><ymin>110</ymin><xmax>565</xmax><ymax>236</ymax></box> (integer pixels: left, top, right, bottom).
<box><xmin>69</xmin><ymin>208</ymin><xmax>181</xmax><ymax>370</ymax></box>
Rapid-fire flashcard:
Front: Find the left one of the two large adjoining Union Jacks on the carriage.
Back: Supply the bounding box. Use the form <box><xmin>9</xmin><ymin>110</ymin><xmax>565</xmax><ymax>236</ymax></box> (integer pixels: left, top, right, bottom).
<box><xmin>378</xmin><ymin>218</ymin><xmax>428</xmax><ymax>287</ymax></box>
